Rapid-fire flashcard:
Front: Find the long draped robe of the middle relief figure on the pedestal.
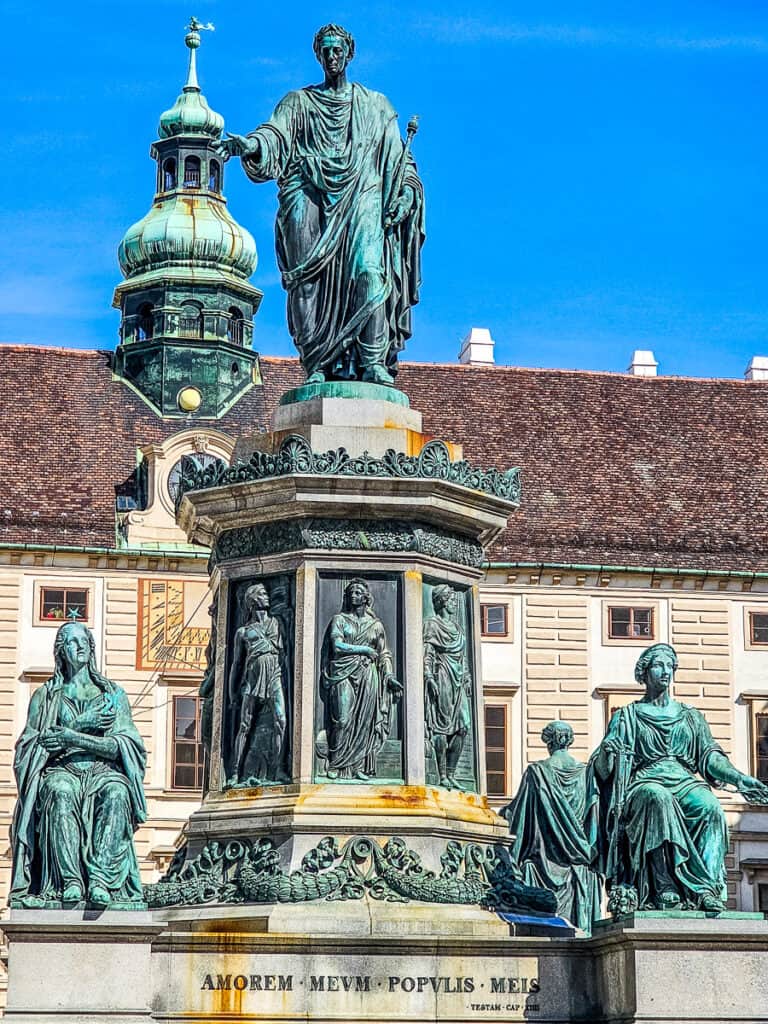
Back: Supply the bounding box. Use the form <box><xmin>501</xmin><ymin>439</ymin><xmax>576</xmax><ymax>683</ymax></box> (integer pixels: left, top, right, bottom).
<box><xmin>321</xmin><ymin>611</ymin><xmax>392</xmax><ymax>778</ymax></box>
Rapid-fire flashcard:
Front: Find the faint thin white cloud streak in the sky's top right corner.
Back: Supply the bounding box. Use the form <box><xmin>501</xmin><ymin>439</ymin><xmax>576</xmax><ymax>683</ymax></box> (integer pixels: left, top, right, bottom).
<box><xmin>417</xmin><ymin>17</ymin><xmax>768</xmax><ymax>53</ymax></box>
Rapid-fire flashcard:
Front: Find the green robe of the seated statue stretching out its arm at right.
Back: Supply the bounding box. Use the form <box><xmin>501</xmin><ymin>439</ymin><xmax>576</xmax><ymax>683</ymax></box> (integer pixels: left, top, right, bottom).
<box><xmin>593</xmin><ymin>701</ymin><xmax>728</xmax><ymax>909</ymax></box>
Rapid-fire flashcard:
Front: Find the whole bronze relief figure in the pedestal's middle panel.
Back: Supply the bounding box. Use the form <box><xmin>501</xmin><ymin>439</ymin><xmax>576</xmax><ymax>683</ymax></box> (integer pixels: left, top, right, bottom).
<box><xmin>314</xmin><ymin>580</ymin><xmax>402</xmax><ymax>782</ymax></box>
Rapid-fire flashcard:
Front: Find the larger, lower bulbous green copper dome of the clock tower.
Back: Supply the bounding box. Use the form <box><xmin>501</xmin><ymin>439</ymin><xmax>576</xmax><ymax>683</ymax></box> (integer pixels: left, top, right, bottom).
<box><xmin>118</xmin><ymin>191</ymin><xmax>257</xmax><ymax>279</ymax></box>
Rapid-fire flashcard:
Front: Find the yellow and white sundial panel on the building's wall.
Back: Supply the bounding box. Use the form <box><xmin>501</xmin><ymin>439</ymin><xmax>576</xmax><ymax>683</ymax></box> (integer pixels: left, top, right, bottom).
<box><xmin>136</xmin><ymin>580</ymin><xmax>211</xmax><ymax>672</ymax></box>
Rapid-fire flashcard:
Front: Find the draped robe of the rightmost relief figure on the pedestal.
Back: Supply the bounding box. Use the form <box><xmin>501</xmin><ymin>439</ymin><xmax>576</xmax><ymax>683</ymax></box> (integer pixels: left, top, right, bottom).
<box><xmin>424</xmin><ymin>615</ymin><xmax>471</xmax><ymax>738</ymax></box>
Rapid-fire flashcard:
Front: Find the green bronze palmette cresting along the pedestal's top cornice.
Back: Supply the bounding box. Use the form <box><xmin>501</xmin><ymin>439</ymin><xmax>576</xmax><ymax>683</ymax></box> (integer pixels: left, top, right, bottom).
<box><xmin>176</xmin><ymin>434</ymin><xmax>520</xmax><ymax>508</ymax></box>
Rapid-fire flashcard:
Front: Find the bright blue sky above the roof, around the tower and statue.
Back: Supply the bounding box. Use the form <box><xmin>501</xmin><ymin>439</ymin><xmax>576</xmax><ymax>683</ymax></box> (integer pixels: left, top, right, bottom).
<box><xmin>0</xmin><ymin>0</ymin><xmax>768</xmax><ymax>377</ymax></box>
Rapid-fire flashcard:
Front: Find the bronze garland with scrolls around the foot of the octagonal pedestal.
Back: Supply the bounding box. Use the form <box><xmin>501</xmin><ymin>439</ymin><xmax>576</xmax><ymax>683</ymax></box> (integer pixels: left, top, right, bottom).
<box><xmin>144</xmin><ymin>836</ymin><xmax>556</xmax><ymax>913</ymax></box>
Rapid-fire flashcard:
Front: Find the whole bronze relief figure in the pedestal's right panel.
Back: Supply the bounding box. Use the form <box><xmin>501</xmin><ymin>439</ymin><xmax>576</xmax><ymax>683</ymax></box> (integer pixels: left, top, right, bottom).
<box><xmin>424</xmin><ymin>584</ymin><xmax>472</xmax><ymax>790</ymax></box>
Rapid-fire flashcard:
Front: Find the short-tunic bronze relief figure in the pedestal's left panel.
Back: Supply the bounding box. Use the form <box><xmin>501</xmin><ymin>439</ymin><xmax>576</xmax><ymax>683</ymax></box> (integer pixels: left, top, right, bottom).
<box><xmin>227</xmin><ymin>583</ymin><xmax>290</xmax><ymax>786</ymax></box>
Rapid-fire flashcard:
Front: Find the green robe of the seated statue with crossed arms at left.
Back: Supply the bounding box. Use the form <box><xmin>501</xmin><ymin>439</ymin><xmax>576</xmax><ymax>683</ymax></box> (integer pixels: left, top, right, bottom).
<box><xmin>10</xmin><ymin>678</ymin><xmax>146</xmax><ymax>902</ymax></box>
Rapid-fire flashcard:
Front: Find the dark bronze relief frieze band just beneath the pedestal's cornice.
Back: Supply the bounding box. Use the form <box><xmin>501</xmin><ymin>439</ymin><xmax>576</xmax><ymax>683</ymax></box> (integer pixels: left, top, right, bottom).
<box><xmin>210</xmin><ymin>518</ymin><xmax>483</xmax><ymax>568</ymax></box>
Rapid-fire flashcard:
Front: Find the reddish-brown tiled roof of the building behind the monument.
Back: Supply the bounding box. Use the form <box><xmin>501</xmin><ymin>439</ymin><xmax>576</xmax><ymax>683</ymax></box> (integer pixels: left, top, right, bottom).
<box><xmin>0</xmin><ymin>345</ymin><xmax>768</xmax><ymax>571</ymax></box>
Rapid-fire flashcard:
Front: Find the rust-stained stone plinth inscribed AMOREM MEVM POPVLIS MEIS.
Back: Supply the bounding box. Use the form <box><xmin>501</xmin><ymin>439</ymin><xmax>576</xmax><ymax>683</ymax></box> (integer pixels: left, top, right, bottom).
<box><xmin>3</xmin><ymin>900</ymin><xmax>768</xmax><ymax>1024</ymax></box>
